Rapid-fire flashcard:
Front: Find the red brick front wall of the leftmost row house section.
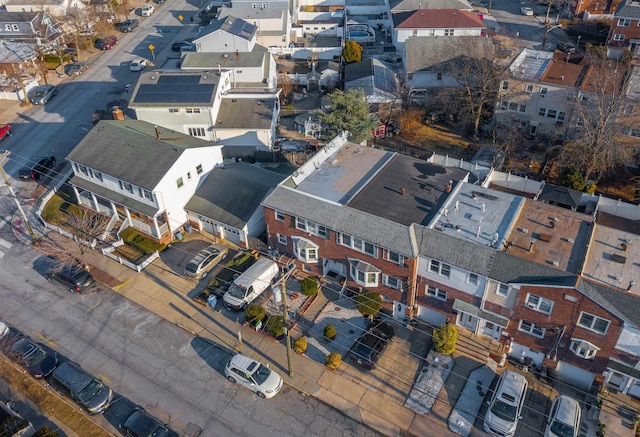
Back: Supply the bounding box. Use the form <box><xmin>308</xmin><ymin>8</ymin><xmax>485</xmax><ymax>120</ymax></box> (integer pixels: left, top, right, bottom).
<box><xmin>264</xmin><ymin>208</ymin><xmax>417</xmax><ymax>308</ymax></box>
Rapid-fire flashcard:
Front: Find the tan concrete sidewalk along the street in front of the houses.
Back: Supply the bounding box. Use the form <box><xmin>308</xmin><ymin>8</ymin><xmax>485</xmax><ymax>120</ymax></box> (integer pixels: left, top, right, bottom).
<box><xmin>12</xmin><ymin>205</ymin><xmax>453</xmax><ymax>436</ymax></box>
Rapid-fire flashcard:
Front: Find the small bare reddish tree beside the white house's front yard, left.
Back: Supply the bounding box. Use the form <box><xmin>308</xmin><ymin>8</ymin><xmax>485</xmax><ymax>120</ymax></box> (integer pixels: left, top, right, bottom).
<box><xmin>35</xmin><ymin>208</ymin><xmax>109</xmax><ymax>271</ymax></box>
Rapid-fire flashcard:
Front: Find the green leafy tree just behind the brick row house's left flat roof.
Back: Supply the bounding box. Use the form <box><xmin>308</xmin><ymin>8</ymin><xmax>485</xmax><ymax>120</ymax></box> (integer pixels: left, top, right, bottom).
<box><xmin>318</xmin><ymin>89</ymin><xmax>375</xmax><ymax>143</ymax></box>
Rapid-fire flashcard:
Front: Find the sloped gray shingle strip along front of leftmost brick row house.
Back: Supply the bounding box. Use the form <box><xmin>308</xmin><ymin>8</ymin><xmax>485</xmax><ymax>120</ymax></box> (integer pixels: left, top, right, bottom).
<box><xmin>263</xmin><ymin>186</ymin><xmax>417</xmax><ymax>258</ymax></box>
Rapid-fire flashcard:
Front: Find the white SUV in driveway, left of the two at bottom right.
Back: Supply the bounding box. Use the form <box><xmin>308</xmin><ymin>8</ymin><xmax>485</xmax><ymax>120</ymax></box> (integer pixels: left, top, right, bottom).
<box><xmin>484</xmin><ymin>370</ymin><xmax>529</xmax><ymax>437</ymax></box>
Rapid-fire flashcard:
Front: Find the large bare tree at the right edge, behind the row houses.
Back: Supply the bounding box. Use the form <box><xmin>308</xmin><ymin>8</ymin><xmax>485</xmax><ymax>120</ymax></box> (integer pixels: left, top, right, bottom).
<box><xmin>562</xmin><ymin>49</ymin><xmax>640</xmax><ymax>183</ymax></box>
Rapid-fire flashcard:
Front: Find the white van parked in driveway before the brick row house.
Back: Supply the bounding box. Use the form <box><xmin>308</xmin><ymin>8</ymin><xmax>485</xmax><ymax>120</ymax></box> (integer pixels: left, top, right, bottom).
<box><xmin>222</xmin><ymin>258</ymin><xmax>280</xmax><ymax>310</ymax></box>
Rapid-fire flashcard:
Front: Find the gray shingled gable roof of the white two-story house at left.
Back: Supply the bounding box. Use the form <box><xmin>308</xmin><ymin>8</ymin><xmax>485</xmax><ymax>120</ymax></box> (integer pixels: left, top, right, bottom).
<box><xmin>67</xmin><ymin>120</ymin><xmax>215</xmax><ymax>190</ymax></box>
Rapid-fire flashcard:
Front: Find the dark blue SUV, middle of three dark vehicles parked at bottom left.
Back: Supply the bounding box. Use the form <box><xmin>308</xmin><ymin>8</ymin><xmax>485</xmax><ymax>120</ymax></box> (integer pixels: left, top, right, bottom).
<box><xmin>50</xmin><ymin>361</ymin><xmax>113</xmax><ymax>414</ymax></box>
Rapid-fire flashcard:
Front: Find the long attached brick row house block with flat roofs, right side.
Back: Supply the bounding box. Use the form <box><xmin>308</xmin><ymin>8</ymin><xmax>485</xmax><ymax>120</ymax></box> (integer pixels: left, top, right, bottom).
<box><xmin>263</xmin><ymin>138</ymin><xmax>640</xmax><ymax>396</ymax></box>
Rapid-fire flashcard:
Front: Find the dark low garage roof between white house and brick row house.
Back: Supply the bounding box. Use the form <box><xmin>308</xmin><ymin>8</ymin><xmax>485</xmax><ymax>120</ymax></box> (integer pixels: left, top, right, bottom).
<box><xmin>185</xmin><ymin>163</ymin><xmax>286</xmax><ymax>229</ymax></box>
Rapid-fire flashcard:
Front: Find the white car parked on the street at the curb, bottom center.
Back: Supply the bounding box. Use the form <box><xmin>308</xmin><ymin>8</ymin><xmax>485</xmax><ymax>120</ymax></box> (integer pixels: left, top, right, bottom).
<box><xmin>224</xmin><ymin>354</ymin><xmax>282</xmax><ymax>399</ymax></box>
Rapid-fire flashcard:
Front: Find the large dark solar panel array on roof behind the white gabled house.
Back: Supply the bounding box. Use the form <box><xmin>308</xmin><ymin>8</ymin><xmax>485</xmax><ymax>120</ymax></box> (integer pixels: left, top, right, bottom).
<box><xmin>135</xmin><ymin>75</ymin><xmax>216</xmax><ymax>103</ymax></box>
